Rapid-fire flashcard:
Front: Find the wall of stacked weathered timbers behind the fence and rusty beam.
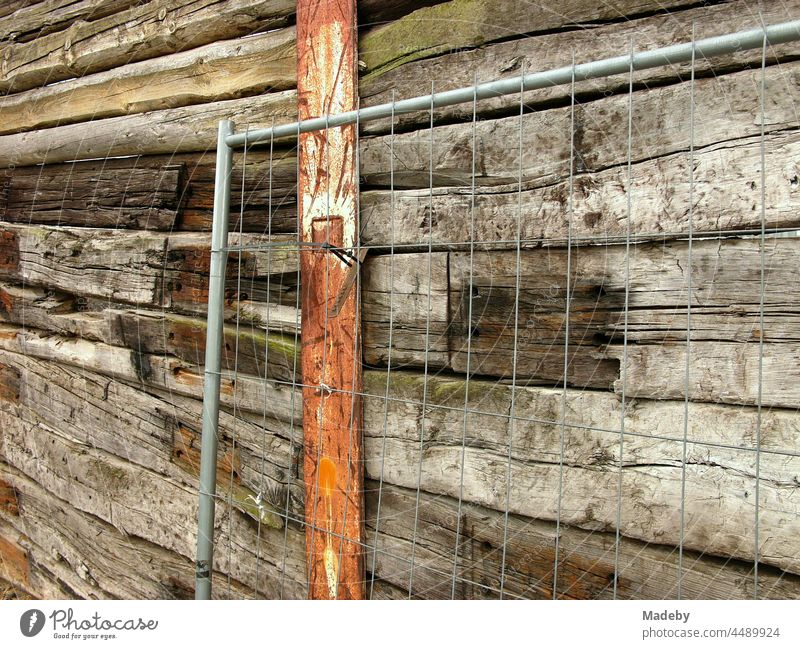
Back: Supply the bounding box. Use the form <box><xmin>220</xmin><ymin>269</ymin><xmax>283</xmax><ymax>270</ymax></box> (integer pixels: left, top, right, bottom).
<box><xmin>0</xmin><ymin>0</ymin><xmax>800</xmax><ymax>598</ymax></box>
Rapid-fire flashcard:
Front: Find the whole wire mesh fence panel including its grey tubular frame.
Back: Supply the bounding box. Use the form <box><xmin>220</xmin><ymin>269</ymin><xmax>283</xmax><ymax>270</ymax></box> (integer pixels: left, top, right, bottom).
<box><xmin>198</xmin><ymin>17</ymin><xmax>800</xmax><ymax>599</ymax></box>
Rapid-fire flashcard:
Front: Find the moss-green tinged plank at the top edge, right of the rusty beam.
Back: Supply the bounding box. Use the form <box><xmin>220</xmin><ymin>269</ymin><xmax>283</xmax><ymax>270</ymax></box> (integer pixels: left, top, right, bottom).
<box><xmin>359</xmin><ymin>0</ymin><xmax>693</xmax><ymax>79</ymax></box>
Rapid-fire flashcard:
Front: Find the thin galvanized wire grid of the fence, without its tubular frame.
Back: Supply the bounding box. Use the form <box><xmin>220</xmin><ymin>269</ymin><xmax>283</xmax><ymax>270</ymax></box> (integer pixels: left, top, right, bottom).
<box><xmin>197</xmin><ymin>19</ymin><xmax>800</xmax><ymax>599</ymax></box>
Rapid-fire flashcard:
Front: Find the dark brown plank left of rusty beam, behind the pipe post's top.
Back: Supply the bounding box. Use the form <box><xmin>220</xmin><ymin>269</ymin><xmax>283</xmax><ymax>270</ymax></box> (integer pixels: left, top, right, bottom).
<box><xmin>0</xmin><ymin>150</ymin><xmax>297</xmax><ymax>234</ymax></box>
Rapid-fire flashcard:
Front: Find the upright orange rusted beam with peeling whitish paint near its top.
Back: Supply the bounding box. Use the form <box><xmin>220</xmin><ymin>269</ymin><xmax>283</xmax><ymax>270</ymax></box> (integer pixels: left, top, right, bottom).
<box><xmin>297</xmin><ymin>0</ymin><xmax>364</xmax><ymax>599</ymax></box>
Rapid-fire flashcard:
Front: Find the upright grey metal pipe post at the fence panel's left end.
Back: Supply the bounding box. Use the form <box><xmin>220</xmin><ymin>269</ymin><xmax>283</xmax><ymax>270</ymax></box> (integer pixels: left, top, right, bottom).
<box><xmin>194</xmin><ymin>120</ymin><xmax>233</xmax><ymax>599</ymax></box>
